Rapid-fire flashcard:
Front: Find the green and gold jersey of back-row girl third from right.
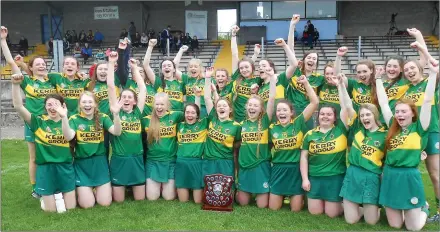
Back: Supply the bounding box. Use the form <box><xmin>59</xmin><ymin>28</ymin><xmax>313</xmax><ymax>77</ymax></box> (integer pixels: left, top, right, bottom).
<box><xmin>347</xmin><ymin>78</ymin><xmax>373</xmax><ymax>112</ymax></box>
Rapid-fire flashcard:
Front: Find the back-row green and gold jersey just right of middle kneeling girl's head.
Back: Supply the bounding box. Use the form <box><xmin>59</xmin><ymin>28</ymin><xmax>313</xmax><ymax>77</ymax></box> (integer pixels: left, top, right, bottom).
<box><xmin>231</xmin><ymin>69</ymin><xmax>261</xmax><ymax>122</ymax></box>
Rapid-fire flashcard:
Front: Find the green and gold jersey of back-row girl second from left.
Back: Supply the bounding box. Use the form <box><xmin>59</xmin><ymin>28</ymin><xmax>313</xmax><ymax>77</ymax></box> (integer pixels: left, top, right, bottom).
<box><xmin>48</xmin><ymin>73</ymin><xmax>90</xmax><ymax>116</ymax></box>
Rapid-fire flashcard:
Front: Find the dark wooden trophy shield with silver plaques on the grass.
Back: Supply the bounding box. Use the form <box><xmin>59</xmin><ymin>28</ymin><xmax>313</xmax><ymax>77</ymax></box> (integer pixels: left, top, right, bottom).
<box><xmin>202</xmin><ymin>174</ymin><xmax>234</xmax><ymax>211</ymax></box>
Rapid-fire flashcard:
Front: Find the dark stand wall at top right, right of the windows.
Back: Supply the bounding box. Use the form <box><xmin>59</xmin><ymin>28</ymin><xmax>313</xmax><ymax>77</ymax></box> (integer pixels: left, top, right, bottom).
<box><xmin>339</xmin><ymin>1</ymin><xmax>436</xmax><ymax>36</ymax></box>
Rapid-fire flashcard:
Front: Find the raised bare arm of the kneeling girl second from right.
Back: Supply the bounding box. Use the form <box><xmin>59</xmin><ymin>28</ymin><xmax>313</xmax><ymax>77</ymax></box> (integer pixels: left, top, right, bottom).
<box><xmin>334</xmin><ymin>73</ymin><xmax>356</xmax><ymax>128</ymax></box>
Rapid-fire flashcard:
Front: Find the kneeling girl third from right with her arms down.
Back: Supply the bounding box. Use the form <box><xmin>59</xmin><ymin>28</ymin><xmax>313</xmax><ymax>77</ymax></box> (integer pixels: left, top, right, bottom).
<box><xmin>300</xmin><ymin>103</ymin><xmax>348</xmax><ymax>217</ymax></box>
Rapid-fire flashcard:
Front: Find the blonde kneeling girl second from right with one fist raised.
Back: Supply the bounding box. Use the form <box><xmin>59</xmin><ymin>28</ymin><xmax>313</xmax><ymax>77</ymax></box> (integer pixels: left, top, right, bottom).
<box><xmin>334</xmin><ymin>74</ymin><xmax>387</xmax><ymax>225</ymax></box>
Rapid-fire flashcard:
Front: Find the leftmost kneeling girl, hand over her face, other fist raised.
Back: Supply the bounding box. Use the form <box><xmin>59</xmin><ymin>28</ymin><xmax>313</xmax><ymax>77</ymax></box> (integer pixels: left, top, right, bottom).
<box><xmin>11</xmin><ymin>74</ymin><xmax>76</xmax><ymax>212</ymax></box>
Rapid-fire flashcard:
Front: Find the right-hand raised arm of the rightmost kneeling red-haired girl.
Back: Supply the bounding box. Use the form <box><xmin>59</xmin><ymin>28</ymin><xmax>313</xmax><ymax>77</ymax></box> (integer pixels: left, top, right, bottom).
<box><xmin>419</xmin><ymin>59</ymin><xmax>439</xmax><ymax>130</ymax></box>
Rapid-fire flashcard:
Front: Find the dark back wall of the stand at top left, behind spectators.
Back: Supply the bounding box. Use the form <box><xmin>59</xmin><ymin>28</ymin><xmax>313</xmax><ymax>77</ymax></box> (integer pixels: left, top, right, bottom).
<box><xmin>1</xmin><ymin>1</ymin><xmax>238</xmax><ymax>44</ymax></box>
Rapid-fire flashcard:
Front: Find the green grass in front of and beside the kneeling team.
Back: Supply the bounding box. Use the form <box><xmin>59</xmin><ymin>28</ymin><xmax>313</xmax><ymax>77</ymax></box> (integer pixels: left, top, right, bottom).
<box><xmin>1</xmin><ymin>140</ymin><xmax>439</xmax><ymax>231</ymax></box>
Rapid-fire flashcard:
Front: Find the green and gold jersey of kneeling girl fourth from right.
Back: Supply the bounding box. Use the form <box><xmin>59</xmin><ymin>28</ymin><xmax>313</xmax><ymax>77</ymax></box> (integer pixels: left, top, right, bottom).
<box><xmin>269</xmin><ymin>113</ymin><xmax>307</xmax><ymax>163</ymax></box>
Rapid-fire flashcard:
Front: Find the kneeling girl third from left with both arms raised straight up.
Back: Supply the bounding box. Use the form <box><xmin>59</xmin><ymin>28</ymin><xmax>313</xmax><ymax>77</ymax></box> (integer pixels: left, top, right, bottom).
<box><xmin>107</xmin><ymin>52</ymin><xmax>146</xmax><ymax>202</ymax></box>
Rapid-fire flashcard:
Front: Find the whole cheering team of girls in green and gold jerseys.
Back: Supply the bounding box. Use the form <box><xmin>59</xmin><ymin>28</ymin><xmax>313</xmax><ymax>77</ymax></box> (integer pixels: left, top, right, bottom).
<box><xmin>1</xmin><ymin>15</ymin><xmax>440</xmax><ymax>230</ymax></box>
